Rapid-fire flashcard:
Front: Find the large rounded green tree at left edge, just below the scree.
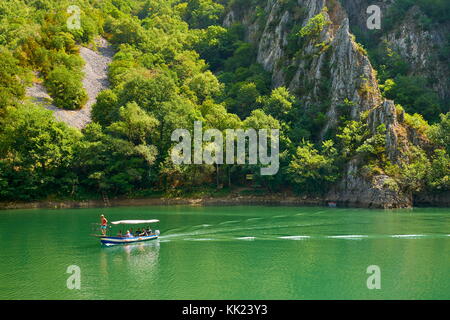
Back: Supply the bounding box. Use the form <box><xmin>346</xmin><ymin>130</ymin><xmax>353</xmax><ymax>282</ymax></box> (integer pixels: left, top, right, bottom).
<box><xmin>0</xmin><ymin>104</ymin><xmax>81</xmax><ymax>199</ymax></box>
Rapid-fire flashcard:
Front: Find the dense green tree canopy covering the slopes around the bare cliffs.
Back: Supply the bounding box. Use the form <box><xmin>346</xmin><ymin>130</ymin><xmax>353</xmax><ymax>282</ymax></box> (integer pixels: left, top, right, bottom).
<box><xmin>0</xmin><ymin>0</ymin><xmax>450</xmax><ymax>200</ymax></box>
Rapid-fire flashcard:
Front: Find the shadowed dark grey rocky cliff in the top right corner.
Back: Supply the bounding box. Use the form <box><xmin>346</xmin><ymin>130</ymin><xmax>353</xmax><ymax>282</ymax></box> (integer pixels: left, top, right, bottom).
<box><xmin>341</xmin><ymin>0</ymin><xmax>450</xmax><ymax>101</ymax></box>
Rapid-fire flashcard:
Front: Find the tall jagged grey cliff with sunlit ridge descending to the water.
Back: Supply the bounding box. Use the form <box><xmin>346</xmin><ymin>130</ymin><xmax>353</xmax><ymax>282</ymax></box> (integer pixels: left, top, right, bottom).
<box><xmin>224</xmin><ymin>0</ymin><xmax>434</xmax><ymax>208</ymax></box>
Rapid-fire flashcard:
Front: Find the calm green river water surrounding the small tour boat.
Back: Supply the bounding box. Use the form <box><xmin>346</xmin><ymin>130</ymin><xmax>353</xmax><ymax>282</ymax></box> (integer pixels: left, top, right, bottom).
<box><xmin>0</xmin><ymin>206</ymin><xmax>450</xmax><ymax>299</ymax></box>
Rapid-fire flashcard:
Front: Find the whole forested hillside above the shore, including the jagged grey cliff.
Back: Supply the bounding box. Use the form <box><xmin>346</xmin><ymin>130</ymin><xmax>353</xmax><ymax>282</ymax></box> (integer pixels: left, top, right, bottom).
<box><xmin>0</xmin><ymin>0</ymin><xmax>450</xmax><ymax>207</ymax></box>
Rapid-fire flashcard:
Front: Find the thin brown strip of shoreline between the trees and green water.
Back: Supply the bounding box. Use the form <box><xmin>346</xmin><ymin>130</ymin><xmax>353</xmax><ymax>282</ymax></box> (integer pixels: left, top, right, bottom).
<box><xmin>0</xmin><ymin>194</ymin><xmax>450</xmax><ymax>210</ymax></box>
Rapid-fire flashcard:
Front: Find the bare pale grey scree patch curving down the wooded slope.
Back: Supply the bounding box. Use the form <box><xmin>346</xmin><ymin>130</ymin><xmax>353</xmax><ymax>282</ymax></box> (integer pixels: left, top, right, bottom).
<box><xmin>27</xmin><ymin>38</ymin><xmax>114</xmax><ymax>129</ymax></box>
